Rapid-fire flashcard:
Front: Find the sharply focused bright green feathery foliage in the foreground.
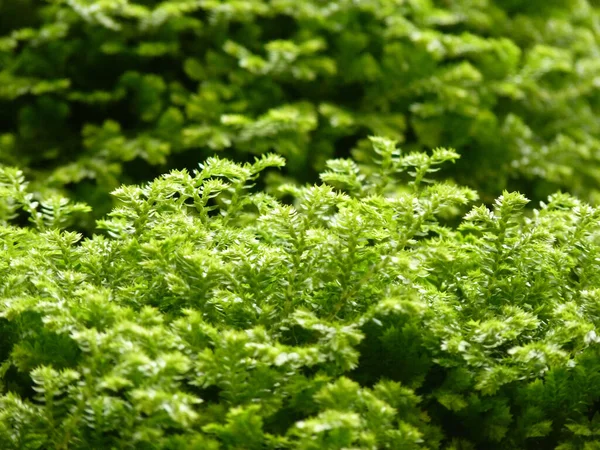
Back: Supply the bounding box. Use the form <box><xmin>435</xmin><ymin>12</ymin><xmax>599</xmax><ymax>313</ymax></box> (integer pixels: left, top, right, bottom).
<box><xmin>0</xmin><ymin>138</ymin><xmax>600</xmax><ymax>450</ymax></box>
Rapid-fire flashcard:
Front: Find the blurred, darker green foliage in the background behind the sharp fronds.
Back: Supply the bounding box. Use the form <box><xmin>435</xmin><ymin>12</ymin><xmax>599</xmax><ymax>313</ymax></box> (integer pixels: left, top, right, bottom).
<box><xmin>0</xmin><ymin>0</ymin><xmax>600</xmax><ymax>221</ymax></box>
